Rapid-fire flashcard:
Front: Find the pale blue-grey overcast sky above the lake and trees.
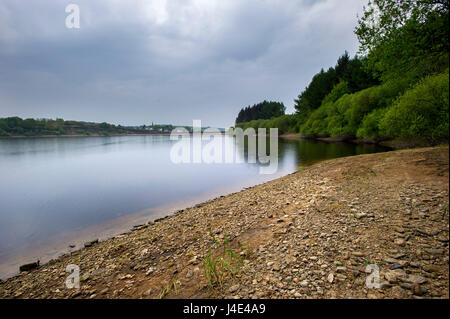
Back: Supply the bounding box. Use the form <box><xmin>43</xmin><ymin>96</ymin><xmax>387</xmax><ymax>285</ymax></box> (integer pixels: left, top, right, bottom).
<box><xmin>0</xmin><ymin>0</ymin><xmax>367</xmax><ymax>127</ymax></box>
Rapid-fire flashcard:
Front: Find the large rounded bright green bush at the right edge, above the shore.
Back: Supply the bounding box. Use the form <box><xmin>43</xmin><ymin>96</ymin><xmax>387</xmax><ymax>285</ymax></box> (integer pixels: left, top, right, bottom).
<box><xmin>379</xmin><ymin>73</ymin><xmax>449</xmax><ymax>143</ymax></box>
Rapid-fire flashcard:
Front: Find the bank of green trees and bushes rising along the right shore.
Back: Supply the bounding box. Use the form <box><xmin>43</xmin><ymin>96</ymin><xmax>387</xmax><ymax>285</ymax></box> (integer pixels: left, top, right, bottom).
<box><xmin>237</xmin><ymin>0</ymin><xmax>449</xmax><ymax>144</ymax></box>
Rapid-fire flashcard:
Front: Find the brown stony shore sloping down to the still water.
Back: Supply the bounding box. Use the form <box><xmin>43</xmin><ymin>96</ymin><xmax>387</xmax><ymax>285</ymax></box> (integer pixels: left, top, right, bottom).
<box><xmin>0</xmin><ymin>147</ymin><xmax>449</xmax><ymax>299</ymax></box>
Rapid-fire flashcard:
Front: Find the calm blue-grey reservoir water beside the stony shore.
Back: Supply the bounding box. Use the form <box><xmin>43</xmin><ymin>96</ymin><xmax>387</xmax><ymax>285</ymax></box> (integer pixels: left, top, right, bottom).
<box><xmin>0</xmin><ymin>136</ymin><xmax>387</xmax><ymax>277</ymax></box>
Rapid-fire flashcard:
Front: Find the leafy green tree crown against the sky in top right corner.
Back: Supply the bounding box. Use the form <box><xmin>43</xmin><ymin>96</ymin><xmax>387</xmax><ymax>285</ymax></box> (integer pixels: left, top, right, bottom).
<box><xmin>355</xmin><ymin>0</ymin><xmax>449</xmax><ymax>80</ymax></box>
